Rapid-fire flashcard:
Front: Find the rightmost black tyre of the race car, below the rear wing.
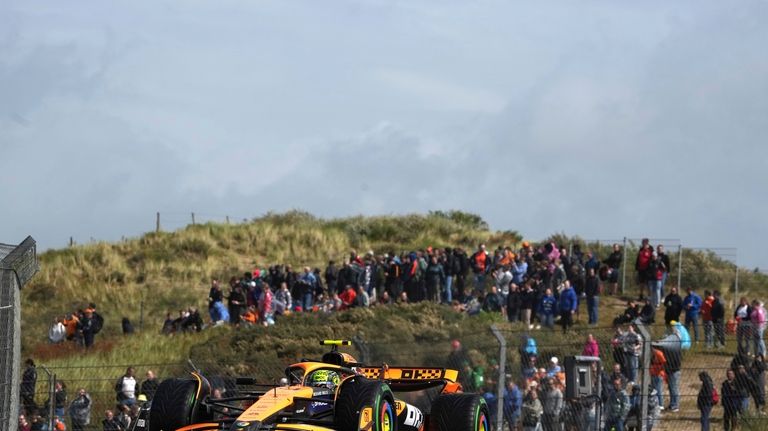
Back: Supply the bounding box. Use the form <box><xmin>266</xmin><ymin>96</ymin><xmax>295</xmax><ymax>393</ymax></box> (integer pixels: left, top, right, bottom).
<box><xmin>429</xmin><ymin>394</ymin><xmax>491</xmax><ymax>431</ymax></box>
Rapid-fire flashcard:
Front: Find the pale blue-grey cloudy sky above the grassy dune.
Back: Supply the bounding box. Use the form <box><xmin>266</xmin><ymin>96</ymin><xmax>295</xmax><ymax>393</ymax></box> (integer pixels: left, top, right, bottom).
<box><xmin>0</xmin><ymin>0</ymin><xmax>768</xmax><ymax>268</ymax></box>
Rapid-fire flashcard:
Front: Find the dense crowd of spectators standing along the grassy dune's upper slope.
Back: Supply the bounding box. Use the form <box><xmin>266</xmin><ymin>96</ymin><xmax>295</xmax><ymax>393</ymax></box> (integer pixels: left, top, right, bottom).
<box><xmin>200</xmin><ymin>242</ymin><xmax>636</xmax><ymax>330</ymax></box>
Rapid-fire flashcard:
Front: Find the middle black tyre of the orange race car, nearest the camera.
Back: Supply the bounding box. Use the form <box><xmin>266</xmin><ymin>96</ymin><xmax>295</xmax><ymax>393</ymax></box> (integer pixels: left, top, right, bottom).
<box><xmin>334</xmin><ymin>376</ymin><xmax>397</xmax><ymax>431</ymax></box>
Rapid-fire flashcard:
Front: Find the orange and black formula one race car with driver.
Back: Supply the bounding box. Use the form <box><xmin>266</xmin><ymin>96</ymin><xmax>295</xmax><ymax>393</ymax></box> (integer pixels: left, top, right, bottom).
<box><xmin>134</xmin><ymin>340</ymin><xmax>490</xmax><ymax>431</ymax></box>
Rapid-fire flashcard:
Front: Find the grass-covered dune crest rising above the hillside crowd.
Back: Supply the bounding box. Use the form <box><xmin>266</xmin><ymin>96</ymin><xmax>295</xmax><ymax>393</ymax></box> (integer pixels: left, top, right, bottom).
<box><xmin>22</xmin><ymin>211</ymin><xmax>521</xmax><ymax>352</ymax></box>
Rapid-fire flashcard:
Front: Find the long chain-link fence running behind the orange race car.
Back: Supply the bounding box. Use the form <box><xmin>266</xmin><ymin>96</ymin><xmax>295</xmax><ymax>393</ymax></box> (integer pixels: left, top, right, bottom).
<box><xmin>25</xmin><ymin>323</ymin><xmax>768</xmax><ymax>431</ymax></box>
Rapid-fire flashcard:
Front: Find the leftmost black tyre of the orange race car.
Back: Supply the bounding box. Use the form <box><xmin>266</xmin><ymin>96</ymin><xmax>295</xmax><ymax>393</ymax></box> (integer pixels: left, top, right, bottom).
<box><xmin>149</xmin><ymin>379</ymin><xmax>210</xmax><ymax>431</ymax></box>
